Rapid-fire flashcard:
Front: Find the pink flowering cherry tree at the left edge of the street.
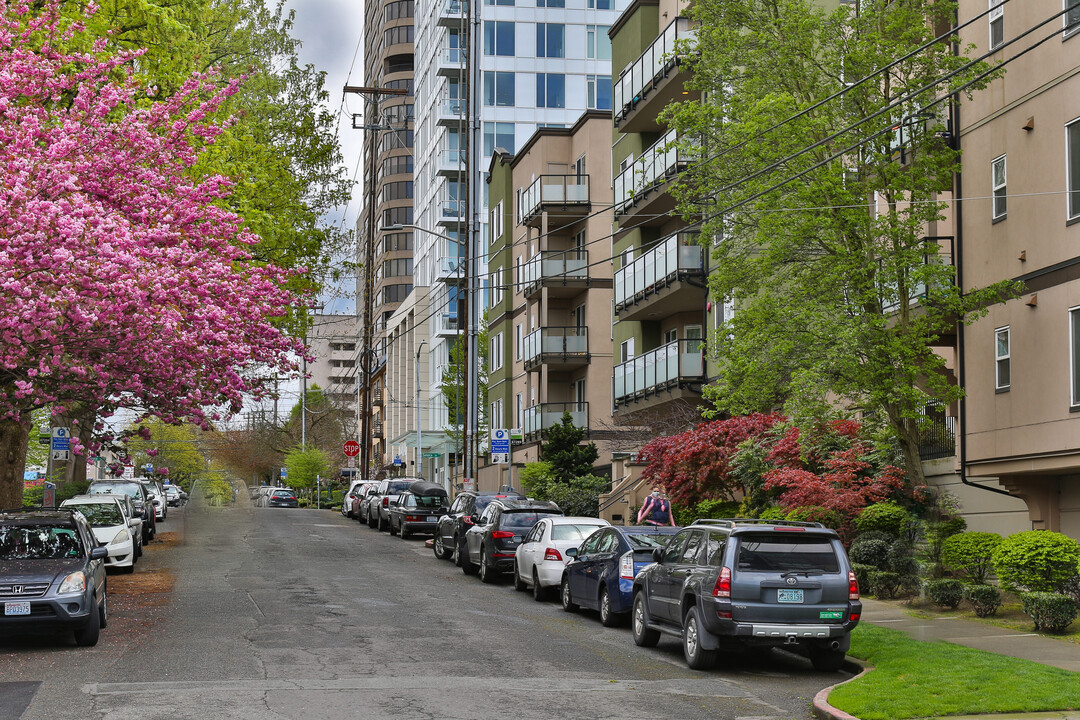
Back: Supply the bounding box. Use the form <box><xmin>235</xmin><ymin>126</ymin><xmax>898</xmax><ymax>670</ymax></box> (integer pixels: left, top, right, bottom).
<box><xmin>0</xmin><ymin>0</ymin><xmax>305</xmax><ymax>507</ymax></box>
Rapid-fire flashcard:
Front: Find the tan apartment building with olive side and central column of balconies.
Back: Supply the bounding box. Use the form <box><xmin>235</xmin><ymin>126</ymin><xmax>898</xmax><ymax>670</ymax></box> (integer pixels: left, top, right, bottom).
<box><xmin>477</xmin><ymin>111</ymin><xmax>619</xmax><ymax>496</ymax></box>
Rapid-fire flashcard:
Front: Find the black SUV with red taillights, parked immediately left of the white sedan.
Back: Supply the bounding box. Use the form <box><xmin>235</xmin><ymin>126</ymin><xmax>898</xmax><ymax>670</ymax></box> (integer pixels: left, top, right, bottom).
<box><xmin>461</xmin><ymin>498</ymin><xmax>563</xmax><ymax>583</ymax></box>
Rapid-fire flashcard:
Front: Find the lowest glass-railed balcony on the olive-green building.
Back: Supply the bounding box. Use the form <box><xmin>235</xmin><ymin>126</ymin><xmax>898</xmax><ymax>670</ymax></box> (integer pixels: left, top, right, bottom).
<box><xmin>611</xmin><ymin>340</ymin><xmax>705</xmax><ymax>409</ymax></box>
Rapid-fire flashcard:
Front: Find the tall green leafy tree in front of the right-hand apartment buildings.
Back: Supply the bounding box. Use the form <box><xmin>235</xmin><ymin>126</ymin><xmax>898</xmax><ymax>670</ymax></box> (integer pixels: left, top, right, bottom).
<box><xmin>664</xmin><ymin>0</ymin><xmax>1016</xmax><ymax>485</ymax></box>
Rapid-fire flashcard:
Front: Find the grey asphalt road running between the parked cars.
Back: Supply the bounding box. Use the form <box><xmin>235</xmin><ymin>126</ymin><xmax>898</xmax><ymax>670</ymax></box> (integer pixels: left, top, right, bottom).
<box><xmin>0</xmin><ymin>492</ymin><xmax>847</xmax><ymax>720</ymax></box>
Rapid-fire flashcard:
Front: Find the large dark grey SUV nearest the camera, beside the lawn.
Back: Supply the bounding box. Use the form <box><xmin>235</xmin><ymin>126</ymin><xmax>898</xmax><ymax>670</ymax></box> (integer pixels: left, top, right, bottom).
<box><xmin>631</xmin><ymin>519</ymin><xmax>863</xmax><ymax>670</ymax></box>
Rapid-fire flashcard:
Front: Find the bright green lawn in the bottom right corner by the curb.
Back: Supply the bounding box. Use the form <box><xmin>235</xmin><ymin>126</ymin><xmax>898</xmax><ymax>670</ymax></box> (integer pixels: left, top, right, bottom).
<box><xmin>828</xmin><ymin>624</ymin><xmax>1080</xmax><ymax>720</ymax></box>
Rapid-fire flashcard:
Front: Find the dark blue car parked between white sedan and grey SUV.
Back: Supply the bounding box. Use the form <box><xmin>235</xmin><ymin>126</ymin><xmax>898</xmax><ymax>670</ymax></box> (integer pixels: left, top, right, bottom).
<box><xmin>562</xmin><ymin>526</ymin><xmax>679</xmax><ymax>627</ymax></box>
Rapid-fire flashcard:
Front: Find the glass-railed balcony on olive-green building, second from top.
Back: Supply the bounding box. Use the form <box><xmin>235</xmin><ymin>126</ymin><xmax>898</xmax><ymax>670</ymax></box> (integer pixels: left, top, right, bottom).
<box><xmin>613</xmin><ymin>131</ymin><xmax>698</xmax><ymax>226</ymax></box>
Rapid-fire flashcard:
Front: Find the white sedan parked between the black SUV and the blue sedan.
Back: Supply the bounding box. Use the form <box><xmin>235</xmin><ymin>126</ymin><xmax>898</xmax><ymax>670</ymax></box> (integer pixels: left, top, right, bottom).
<box><xmin>514</xmin><ymin>517</ymin><xmax>611</xmax><ymax>600</ymax></box>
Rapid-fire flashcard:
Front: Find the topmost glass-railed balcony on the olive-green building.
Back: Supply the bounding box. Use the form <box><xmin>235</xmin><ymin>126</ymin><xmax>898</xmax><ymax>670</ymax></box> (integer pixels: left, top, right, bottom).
<box><xmin>611</xmin><ymin>17</ymin><xmax>698</xmax><ymax>133</ymax></box>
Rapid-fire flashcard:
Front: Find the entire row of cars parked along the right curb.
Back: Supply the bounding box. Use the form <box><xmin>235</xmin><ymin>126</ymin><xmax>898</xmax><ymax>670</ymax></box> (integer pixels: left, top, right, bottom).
<box><xmin>342</xmin><ymin>478</ymin><xmax>862</xmax><ymax>670</ymax></box>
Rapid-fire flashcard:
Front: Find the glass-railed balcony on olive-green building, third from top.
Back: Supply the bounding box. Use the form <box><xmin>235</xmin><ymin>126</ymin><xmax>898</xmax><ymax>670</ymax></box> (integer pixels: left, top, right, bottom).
<box><xmin>615</xmin><ymin>232</ymin><xmax>706</xmax><ymax>321</ymax></box>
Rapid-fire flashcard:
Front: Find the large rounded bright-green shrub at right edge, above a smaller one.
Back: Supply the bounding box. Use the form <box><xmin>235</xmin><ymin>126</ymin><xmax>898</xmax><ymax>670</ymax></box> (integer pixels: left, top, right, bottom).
<box><xmin>994</xmin><ymin>530</ymin><xmax>1080</xmax><ymax>593</ymax></box>
